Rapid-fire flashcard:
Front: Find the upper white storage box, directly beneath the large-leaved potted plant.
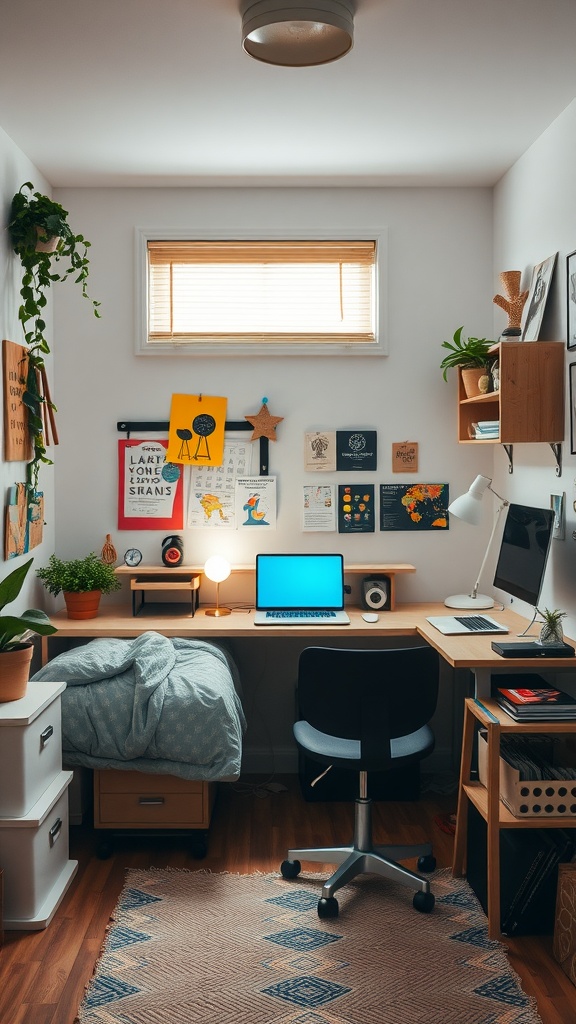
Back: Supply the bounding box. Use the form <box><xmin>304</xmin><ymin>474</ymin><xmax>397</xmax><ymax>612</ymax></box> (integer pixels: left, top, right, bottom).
<box><xmin>0</xmin><ymin>682</ymin><xmax>66</xmax><ymax>822</ymax></box>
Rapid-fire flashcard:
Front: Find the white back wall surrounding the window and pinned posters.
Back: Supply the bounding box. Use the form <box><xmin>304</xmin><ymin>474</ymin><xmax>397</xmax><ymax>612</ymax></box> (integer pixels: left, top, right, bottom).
<box><xmin>51</xmin><ymin>188</ymin><xmax>492</xmax><ymax>600</ymax></box>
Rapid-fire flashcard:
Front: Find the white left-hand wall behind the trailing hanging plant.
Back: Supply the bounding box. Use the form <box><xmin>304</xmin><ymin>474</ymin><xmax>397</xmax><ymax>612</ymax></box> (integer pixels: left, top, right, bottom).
<box><xmin>0</xmin><ymin>128</ymin><xmax>54</xmax><ymax>613</ymax></box>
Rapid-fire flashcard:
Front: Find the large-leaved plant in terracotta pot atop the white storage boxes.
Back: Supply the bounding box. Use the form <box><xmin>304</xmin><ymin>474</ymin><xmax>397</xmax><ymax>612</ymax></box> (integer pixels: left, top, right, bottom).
<box><xmin>0</xmin><ymin>558</ymin><xmax>56</xmax><ymax>703</ymax></box>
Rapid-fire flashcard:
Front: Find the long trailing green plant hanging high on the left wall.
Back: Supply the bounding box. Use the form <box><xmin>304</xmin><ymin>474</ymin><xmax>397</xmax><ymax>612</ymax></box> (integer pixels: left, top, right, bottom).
<box><xmin>8</xmin><ymin>181</ymin><xmax>100</xmax><ymax>490</ymax></box>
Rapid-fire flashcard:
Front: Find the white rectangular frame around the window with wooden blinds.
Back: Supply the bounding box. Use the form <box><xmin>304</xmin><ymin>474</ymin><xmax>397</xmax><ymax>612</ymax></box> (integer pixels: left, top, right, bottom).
<box><xmin>134</xmin><ymin>227</ymin><xmax>387</xmax><ymax>357</ymax></box>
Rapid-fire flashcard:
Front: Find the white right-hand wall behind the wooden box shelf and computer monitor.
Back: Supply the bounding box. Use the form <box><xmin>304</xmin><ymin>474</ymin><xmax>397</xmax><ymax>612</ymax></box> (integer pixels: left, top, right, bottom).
<box><xmin>494</xmin><ymin>101</ymin><xmax>576</xmax><ymax>636</ymax></box>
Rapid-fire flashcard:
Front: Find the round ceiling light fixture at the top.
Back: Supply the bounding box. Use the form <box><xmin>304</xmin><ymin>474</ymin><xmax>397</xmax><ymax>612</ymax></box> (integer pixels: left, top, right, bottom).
<box><xmin>241</xmin><ymin>0</ymin><xmax>355</xmax><ymax>68</ymax></box>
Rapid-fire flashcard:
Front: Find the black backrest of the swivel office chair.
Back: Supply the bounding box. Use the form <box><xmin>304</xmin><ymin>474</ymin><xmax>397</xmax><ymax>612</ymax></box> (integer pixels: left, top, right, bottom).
<box><xmin>298</xmin><ymin>646</ymin><xmax>440</xmax><ymax>762</ymax></box>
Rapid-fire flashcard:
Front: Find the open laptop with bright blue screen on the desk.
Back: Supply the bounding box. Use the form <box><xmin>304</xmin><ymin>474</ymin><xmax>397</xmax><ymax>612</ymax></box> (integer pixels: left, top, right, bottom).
<box><xmin>254</xmin><ymin>555</ymin><xmax>349</xmax><ymax>626</ymax></box>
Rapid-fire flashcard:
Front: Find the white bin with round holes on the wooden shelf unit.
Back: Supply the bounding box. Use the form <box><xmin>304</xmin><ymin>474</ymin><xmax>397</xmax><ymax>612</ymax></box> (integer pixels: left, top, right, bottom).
<box><xmin>478</xmin><ymin>730</ymin><xmax>576</xmax><ymax>827</ymax></box>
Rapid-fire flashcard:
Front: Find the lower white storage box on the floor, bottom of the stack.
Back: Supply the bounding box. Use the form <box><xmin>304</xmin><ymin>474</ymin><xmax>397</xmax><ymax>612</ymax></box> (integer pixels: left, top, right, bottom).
<box><xmin>0</xmin><ymin>771</ymin><xmax>76</xmax><ymax>928</ymax></box>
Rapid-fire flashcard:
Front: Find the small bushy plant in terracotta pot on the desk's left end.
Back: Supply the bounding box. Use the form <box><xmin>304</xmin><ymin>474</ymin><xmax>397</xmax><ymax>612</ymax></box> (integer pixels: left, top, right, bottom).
<box><xmin>36</xmin><ymin>551</ymin><xmax>121</xmax><ymax>618</ymax></box>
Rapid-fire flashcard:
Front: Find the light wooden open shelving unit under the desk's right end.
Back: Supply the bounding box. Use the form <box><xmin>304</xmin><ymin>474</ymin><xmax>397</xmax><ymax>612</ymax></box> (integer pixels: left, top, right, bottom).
<box><xmin>452</xmin><ymin>697</ymin><xmax>576</xmax><ymax>939</ymax></box>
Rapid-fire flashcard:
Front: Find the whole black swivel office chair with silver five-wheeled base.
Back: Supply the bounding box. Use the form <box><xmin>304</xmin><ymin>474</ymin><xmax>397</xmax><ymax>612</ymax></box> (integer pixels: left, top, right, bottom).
<box><xmin>280</xmin><ymin>647</ymin><xmax>439</xmax><ymax>918</ymax></box>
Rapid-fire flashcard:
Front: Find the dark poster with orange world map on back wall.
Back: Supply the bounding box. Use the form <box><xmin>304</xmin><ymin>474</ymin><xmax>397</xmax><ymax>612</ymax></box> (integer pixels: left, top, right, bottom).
<box><xmin>380</xmin><ymin>483</ymin><xmax>450</xmax><ymax>530</ymax></box>
